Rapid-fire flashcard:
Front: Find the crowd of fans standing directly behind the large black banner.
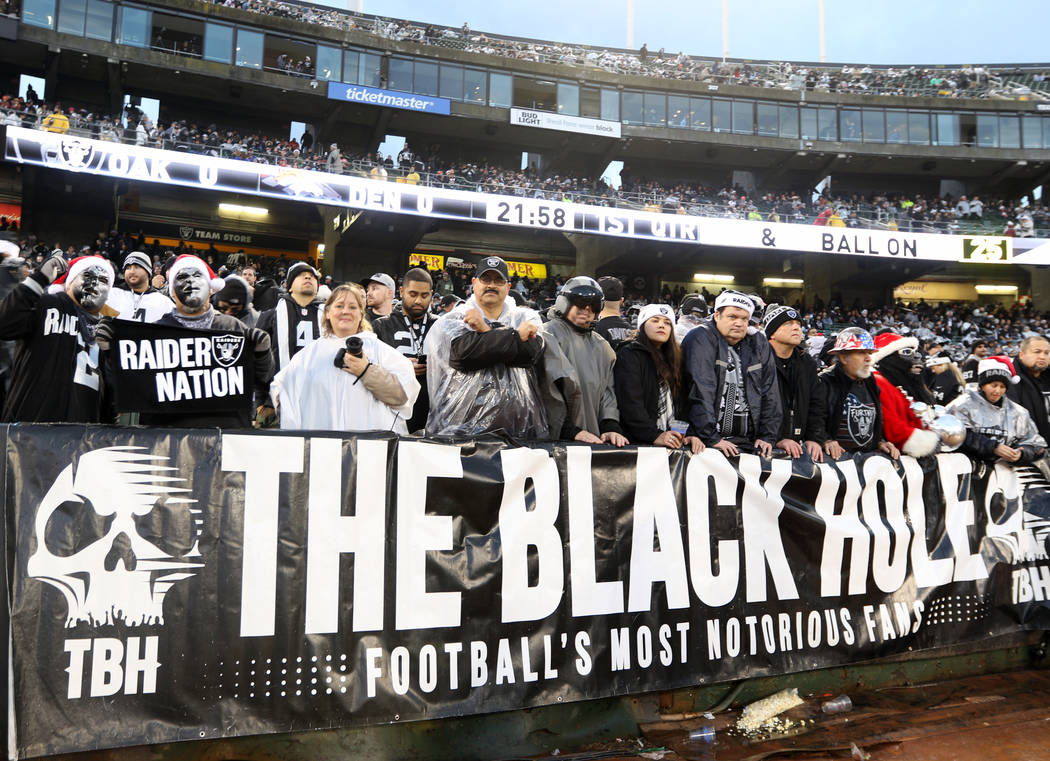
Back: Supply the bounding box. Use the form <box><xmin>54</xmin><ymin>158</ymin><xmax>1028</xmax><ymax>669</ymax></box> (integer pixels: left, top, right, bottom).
<box><xmin>8</xmin><ymin>233</ymin><xmax>1050</xmax><ymax>480</ymax></box>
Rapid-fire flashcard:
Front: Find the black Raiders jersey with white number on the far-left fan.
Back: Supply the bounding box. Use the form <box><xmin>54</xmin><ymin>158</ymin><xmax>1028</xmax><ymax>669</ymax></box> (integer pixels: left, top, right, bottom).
<box><xmin>0</xmin><ymin>276</ymin><xmax>112</xmax><ymax>423</ymax></box>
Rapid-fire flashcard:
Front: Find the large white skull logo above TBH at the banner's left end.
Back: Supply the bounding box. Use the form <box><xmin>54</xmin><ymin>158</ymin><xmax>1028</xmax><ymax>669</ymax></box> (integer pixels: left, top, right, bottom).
<box><xmin>27</xmin><ymin>446</ymin><xmax>204</xmax><ymax>627</ymax></box>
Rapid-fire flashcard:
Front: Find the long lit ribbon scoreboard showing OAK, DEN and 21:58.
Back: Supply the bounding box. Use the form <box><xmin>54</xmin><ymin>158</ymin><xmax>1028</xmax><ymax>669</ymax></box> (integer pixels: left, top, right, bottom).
<box><xmin>4</xmin><ymin>127</ymin><xmax>1012</xmax><ymax>262</ymax></box>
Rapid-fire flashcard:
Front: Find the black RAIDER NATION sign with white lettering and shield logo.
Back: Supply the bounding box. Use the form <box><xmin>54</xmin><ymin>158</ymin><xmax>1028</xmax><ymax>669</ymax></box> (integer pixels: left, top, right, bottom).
<box><xmin>109</xmin><ymin>320</ymin><xmax>251</xmax><ymax>414</ymax></box>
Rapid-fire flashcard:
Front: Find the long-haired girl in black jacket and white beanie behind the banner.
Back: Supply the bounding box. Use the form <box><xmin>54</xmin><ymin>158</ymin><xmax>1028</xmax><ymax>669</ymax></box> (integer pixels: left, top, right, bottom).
<box><xmin>613</xmin><ymin>304</ymin><xmax>704</xmax><ymax>455</ymax></box>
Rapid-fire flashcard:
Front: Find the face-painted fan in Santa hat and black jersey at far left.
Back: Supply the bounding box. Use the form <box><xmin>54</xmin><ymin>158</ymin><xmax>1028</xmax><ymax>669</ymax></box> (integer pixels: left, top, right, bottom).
<box><xmin>0</xmin><ymin>256</ymin><xmax>113</xmax><ymax>423</ymax></box>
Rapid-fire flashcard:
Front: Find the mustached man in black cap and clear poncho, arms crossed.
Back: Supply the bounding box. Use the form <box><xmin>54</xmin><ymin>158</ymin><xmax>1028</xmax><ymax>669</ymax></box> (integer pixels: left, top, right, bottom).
<box><xmin>423</xmin><ymin>256</ymin><xmax>548</xmax><ymax>439</ymax></box>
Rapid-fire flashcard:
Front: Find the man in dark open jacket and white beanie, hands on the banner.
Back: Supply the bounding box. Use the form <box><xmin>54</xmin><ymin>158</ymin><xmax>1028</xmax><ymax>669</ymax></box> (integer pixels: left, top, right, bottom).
<box><xmin>681</xmin><ymin>291</ymin><xmax>782</xmax><ymax>457</ymax></box>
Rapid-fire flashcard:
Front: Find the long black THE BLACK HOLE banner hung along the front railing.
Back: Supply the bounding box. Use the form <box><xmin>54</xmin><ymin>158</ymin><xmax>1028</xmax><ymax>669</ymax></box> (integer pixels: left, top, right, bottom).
<box><xmin>6</xmin><ymin>425</ymin><xmax>1050</xmax><ymax>758</ymax></box>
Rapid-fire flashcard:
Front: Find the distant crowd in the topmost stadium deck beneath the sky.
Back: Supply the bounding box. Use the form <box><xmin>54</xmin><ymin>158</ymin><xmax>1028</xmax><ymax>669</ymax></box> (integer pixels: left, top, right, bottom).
<box><xmin>200</xmin><ymin>0</ymin><xmax>1047</xmax><ymax>98</ymax></box>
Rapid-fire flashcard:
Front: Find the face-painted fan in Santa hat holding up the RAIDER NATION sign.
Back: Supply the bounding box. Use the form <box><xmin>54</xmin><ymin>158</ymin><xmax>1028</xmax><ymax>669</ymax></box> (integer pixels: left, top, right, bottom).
<box><xmin>140</xmin><ymin>254</ymin><xmax>273</xmax><ymax>428</ymax></box>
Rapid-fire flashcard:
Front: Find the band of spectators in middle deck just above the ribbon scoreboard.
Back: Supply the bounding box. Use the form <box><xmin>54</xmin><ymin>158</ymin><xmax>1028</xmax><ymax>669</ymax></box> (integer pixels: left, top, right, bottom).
<box><xmin>6</xmin><ymin>89</ymin><xmax>1050</xmax><ymax>237</ymax></box>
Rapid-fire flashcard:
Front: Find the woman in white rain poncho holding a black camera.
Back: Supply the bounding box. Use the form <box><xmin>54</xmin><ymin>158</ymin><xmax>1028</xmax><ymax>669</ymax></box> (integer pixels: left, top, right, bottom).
<box><xmin>271</xmin><ymin>286</ymin><xmax>419</xmax><ymax>435</ymax></box>
